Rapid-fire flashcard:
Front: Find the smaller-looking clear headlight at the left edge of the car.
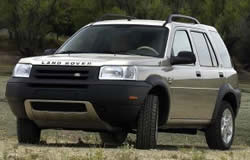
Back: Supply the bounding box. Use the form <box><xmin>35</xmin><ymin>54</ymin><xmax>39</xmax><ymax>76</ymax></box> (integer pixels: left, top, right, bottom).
<box><xmin>12</xmin><ymin>64</ymin><xmax>32</xmax><ymax>78</ymax></box>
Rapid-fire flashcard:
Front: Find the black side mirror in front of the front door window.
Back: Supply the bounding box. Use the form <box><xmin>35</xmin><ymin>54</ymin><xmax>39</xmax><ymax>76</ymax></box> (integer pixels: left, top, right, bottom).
<box><xmin>170</xmin><ymin>51</ymin><xmax>196</xmax><ymax>65</ymax></box>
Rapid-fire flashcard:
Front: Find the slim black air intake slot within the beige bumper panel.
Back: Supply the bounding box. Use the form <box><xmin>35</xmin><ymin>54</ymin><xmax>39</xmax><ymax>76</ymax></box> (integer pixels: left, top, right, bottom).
<box><xmin>31</xmin><ymin>102</ymin><xmax>87</xmax><ymax>112</ymax></box>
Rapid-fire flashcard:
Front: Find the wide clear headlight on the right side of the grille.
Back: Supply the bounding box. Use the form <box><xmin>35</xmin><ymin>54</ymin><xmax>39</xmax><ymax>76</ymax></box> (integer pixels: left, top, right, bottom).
<box><xmin>99</xmin><ymin>66</ymin><xmax>137</xmax><ymax>80</ymax></box>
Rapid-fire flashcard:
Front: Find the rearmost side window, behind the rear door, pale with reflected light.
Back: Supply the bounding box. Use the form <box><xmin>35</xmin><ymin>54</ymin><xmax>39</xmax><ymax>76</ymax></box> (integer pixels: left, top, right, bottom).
<box><xmin>211</xmin><ymin>32</ymin><xmax>232</xmax><ymax>68</ymax></box>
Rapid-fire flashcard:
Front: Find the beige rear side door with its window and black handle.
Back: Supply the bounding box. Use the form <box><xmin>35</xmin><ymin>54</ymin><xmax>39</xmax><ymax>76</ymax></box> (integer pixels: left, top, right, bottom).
<box><xmin>191</xmin><ymin>30</ymin><xmax>225</xmax><ymax>119</ymax></box>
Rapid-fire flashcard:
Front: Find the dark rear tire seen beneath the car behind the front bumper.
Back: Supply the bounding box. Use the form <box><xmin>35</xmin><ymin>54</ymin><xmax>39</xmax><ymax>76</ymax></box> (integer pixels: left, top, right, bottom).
<box><xmin>99</xmin><ymin>131</ymin><xmax>128</xmax><ymax>146</ymax></box>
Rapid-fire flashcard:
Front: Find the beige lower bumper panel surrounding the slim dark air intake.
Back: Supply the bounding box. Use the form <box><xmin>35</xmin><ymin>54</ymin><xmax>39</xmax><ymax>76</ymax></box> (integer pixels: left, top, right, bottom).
<box><xmin>24</xmin><ymin>99</ymin><xmax>114</xmax><ymax>131</ymax></box>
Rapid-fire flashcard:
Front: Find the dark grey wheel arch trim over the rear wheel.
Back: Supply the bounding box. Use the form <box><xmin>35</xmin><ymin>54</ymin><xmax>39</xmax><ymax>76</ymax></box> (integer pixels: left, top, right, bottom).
<box><xmin>212</xmin><ymin>84</ymin><xmax>241</xmax><ymax>122</ymax></box>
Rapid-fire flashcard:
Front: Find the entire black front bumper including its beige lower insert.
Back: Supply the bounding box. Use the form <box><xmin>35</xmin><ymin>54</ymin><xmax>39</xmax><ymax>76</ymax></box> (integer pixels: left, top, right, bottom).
<box><xmin>6</xmin><ymin>78</ymin><xmax>151</xmax><ymax>131</ymax></box>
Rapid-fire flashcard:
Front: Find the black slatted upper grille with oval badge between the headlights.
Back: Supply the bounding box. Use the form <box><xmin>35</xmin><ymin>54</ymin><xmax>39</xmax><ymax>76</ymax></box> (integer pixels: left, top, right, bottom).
<box><xmin>31</xmin><ymin>66</ymin><xmax>99</xmax><ymax>81</ymax></box>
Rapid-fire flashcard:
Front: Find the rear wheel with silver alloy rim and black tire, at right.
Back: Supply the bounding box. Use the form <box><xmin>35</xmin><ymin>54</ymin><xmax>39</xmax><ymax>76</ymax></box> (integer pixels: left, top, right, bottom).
<box><xmin>205</xmin><ymin>101</ymin><xmax>235</xmax><ymax>150</ymax></box>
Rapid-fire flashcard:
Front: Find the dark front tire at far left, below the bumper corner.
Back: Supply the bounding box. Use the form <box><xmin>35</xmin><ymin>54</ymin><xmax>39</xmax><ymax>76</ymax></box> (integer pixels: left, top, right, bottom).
<box><xmin>17</xmin><ymin>119</ymin><xmax>41</xmax><ymax>144</ymax></box>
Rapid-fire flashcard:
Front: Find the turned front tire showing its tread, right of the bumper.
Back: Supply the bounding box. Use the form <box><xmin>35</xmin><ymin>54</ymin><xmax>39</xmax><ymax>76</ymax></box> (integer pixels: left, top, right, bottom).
<box><xmin>136</xmin><ymin>94</ymin><xmax>159</xmax><ymax>149</ymax></box>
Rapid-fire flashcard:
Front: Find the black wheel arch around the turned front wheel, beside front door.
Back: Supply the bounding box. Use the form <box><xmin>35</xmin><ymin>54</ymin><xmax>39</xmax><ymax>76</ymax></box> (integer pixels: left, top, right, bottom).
<box><xmin>146</xmin><ymin>75</ymin><xmax>170</xmax><ymax>125</ymax></box>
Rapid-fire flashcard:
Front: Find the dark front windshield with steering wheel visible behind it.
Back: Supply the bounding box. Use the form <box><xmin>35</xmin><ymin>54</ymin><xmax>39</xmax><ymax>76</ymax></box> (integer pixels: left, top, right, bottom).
<box><xmin>57</xmin><ymin>25</ymin><xmax>168</xmax><ymax>57</ymax></box>
